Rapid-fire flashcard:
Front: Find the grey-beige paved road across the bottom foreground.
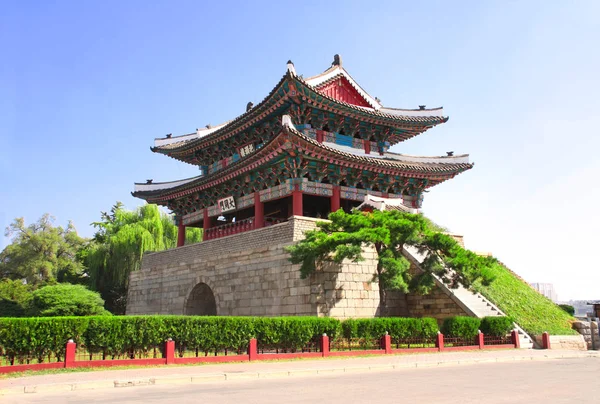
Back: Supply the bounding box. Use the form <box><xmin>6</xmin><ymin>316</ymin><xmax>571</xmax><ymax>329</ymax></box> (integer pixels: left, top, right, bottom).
<box><xmin>1</xmin><ymin>358</ymin><xmax>600</xmax><ymax>404</ymax></box>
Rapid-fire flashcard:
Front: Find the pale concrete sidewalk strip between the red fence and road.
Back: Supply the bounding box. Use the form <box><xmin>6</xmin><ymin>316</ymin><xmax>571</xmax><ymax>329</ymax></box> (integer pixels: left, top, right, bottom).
<box><xmin>0</xmin><ymin>349</ymin><xmax>600</xmax><ymax>395</ymax></box>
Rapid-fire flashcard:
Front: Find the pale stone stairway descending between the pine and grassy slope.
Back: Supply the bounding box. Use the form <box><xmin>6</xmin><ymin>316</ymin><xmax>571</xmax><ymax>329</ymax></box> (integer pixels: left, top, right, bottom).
<box><xmin>404</xmin><ymin>246</ymin><xmax>536</xmax><ymax>349</ymax></box>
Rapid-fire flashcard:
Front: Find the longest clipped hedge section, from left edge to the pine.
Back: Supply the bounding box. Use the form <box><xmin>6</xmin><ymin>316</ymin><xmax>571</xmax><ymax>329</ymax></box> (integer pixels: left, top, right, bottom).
<box><xmin>0</xmin><ymin>316</ymin><xmax>341</xmax><ymax>362</ymax></box>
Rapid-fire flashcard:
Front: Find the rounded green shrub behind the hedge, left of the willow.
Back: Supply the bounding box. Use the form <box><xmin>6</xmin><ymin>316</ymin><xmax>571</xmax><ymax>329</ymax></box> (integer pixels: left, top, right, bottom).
<box><xmin>30</xmin><ymin>284</ymin><xmax>110</xmax><ymax>317</ymax></box>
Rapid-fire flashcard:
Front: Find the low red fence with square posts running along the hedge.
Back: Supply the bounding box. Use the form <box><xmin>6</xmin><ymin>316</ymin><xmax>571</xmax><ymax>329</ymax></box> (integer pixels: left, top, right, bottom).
<box><xmin>0</xmin><ymin>331</ymin><xmax>524</xmax><ymax>373</ymax></box>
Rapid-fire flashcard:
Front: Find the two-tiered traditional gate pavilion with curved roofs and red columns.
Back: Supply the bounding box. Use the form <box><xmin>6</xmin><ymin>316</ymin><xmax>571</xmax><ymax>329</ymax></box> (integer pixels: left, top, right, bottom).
<box><xmin>133</xmin><ymin>55</ymin><xmax>473</xmax><ymax>246</ymax></box>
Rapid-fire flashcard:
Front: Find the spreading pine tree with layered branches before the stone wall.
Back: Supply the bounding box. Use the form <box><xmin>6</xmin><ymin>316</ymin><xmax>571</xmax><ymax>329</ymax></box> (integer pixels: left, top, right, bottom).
<box><xmin>288</xmin><ymin>210</ymin><xmax>496</xmax><ymax>313</ymax></box>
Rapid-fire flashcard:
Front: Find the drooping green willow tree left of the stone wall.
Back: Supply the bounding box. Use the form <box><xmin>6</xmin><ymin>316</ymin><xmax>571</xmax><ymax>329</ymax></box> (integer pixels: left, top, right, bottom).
<box><xmin>84</xmin><ymin>202</ymin><xmax>202</xmax><ymax>314</ymax></box>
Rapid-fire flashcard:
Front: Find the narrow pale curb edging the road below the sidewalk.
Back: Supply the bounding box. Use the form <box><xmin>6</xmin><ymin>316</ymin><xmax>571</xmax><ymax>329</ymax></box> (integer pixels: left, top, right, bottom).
<box><xmin>0</xmin><ymin>352</ymin><xmax>600</xmax><ymax>396</ymax></box>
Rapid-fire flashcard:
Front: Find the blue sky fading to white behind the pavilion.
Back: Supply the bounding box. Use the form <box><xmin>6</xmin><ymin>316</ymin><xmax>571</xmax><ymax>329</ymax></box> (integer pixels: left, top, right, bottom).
<box><xmin>0</xmin><ymin>1</ymin><xmax>600</xmax><ymax>299</ymax></box>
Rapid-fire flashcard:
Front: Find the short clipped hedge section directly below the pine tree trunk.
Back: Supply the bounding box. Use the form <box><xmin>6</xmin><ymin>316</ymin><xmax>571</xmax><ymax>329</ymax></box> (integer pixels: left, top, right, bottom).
<box><xmin>342</xmin><ymin>317</ymin><xmax>439</xmax><ymax>339</ymax></box>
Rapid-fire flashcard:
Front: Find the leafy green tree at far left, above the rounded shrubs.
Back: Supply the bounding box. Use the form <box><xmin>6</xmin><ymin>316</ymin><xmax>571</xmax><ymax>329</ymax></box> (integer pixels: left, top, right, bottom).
<box><xmin>0</xmin><ymin>214</ymin><xmax>85</xmax><ymax>285</ymax></box>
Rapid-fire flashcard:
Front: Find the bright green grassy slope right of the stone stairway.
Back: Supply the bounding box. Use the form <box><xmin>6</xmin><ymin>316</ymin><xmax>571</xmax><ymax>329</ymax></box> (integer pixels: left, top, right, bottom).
<box><xmin>475</xmin><ymin>265</ymin><xmax>577</xmax><ymax>335</ymax></box>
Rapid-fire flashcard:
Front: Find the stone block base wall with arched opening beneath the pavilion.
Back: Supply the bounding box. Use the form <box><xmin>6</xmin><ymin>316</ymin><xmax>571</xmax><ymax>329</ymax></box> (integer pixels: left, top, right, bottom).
<box><xmin>127</xmin><ymin>216</ymin><xmax>466</xmax><ymax>320</ymax></box>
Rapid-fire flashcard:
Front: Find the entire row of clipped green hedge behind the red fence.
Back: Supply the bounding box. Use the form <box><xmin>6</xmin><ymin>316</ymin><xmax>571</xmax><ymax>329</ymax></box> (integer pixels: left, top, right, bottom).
<box><xmin>0</xmin><ymin>316</ymin><xmax>512</xmax><ymax>363</ymax></box>
